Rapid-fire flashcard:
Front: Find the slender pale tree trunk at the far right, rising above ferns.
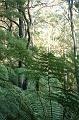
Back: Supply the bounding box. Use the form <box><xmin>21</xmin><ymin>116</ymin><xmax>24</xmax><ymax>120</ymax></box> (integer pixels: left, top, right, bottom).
<box><xmin>69</xmin><ymin>0</ymin><xmax>79</xmax><ymax>93</ymax></box>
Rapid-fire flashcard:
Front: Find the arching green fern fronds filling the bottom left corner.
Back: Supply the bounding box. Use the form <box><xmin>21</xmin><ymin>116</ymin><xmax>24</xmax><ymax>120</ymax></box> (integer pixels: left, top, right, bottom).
<box><xmin>0</xmin><ymin>80</ymin><xmax>36</xmax><ymax>120</ymax></box>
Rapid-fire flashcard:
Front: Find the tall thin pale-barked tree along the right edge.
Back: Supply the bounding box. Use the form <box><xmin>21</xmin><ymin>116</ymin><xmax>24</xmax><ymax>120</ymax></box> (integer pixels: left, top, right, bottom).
<box><xmin>68</xmin><ymin>0</ymin><xmax>79</xmax><ymax>93</ymax></box>
